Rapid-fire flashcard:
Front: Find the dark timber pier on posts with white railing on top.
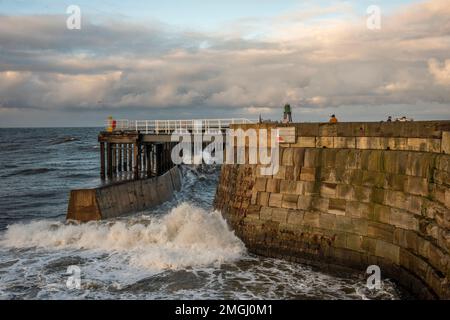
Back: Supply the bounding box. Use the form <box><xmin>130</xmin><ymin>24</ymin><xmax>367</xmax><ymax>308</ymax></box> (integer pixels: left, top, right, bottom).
<box><xmin>98</xmin><ymin>119</ymin><xmax>252</xmax><ymax>181</ymax></box>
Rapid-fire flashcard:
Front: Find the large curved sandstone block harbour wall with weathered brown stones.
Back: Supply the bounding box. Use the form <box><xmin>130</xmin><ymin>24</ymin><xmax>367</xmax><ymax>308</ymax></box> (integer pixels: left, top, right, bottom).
<box><xmin>215</xmin><ymin>121</ymin><xmax>450</xmax><ymax>299</ymax></box>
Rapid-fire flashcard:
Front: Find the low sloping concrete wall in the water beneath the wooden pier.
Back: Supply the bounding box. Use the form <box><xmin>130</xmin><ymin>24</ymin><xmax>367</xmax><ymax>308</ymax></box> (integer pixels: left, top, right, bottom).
<box><xmin>67</xmin><ymin>167</ymin><xmax>181</xmax><ymax>222</ymax></box>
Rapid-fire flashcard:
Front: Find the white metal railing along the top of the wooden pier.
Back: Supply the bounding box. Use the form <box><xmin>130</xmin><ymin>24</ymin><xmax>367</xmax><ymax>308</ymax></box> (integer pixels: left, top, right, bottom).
<box><xmin>106</xmin><ymin>118</ymin><xmax>257</xmax><ymax>134</ymax></box>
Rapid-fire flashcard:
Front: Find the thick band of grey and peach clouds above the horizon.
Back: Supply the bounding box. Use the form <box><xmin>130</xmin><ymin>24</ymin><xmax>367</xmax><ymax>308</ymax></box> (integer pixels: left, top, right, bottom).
<box><xmin>0</xmin><ymin>0</ymin><xmax>450</xmax><ymax>124</ymax></box>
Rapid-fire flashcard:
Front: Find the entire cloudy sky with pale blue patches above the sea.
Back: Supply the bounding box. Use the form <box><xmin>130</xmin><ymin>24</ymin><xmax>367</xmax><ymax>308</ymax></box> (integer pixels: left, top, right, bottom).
<box><xmin>0</xmin><ymin>0</ymin><xmax>450</xmax><ymax>127</ymax></box>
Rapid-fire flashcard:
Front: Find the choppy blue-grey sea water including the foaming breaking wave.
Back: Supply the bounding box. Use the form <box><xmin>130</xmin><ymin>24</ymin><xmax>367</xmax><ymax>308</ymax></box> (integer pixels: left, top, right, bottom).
<box><xmin>0</xmin><ymin>128</ymin><xmax>407</xmax><ymax>299</ymax></box>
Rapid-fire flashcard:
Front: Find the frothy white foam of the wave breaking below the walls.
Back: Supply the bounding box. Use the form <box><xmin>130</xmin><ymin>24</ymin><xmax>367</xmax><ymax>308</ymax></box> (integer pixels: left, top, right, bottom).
<box><xmin>0</xmin><ymin>203</ymin><xmax>245</xmax><ymax>270</ymax></box>
